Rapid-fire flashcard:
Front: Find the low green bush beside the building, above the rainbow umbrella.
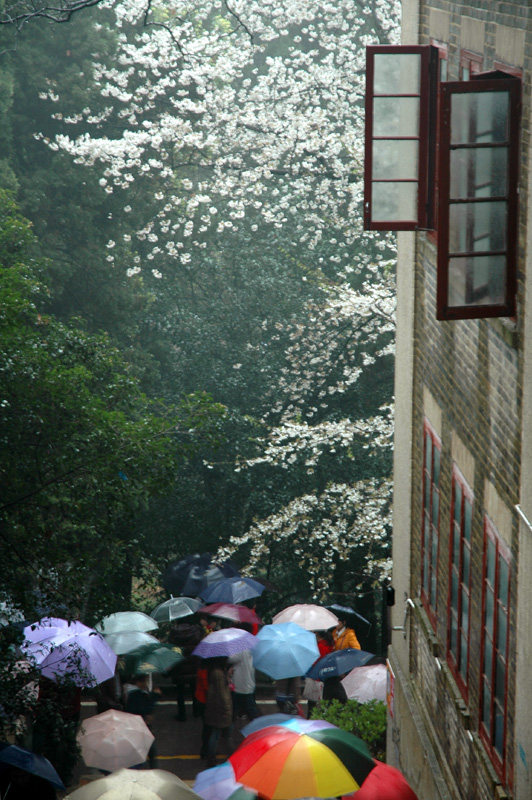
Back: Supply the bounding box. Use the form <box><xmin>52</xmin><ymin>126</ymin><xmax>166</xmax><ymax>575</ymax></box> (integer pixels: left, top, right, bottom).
<box><xmin>312</xmin><ymin>700</ymin><xmax>386</xmax><ymax>761</ymax></box>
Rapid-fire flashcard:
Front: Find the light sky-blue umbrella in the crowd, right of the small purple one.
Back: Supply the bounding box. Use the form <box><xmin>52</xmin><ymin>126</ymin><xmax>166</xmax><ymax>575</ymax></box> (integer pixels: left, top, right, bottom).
<box><xmin>253</xmin><ymin>622</ymin><xmax>320</xmax><ymax>680</ymax></box>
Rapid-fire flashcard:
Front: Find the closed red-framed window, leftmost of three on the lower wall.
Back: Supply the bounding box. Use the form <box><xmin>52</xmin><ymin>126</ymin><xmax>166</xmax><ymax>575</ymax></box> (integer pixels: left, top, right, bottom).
<box><xmin>421</xmin><ymin>419</ymin><xmax>441</xmax><ymax>630</ymax></box>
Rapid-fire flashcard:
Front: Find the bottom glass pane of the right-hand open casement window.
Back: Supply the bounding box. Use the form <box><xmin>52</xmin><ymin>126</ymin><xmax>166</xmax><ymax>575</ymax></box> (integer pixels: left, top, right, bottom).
<box><xmin>447</xmin><ymin>255</ymin><xmax>506</xmax><ymax>307</ymax></box>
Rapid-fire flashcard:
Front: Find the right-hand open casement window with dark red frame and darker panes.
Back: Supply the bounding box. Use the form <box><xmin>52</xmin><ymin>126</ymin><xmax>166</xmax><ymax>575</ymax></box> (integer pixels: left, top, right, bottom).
<box><xmin>437</xmin><ymin>73</ymin><xmax>521</xmax><ymax>320</ymax></box>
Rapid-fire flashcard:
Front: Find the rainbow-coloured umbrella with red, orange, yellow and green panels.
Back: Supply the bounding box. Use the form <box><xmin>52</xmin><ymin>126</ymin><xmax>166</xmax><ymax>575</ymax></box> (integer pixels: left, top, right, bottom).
<box><xmin>229</xmin><ymin>726</ymin><xmax>375</xmax><ymax>800</ymax></box>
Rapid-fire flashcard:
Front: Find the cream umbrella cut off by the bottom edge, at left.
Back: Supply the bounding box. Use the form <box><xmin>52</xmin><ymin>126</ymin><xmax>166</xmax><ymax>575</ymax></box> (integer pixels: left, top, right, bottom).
<box><xmin>65</xmin><ymin>769</ymin><xmax>204</xmax><ymax>800</ymax></box>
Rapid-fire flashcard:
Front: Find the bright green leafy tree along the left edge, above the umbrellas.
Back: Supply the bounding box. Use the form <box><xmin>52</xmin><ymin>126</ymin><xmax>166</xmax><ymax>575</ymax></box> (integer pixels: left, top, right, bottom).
<box><xmin>0</xmin><ymin>193</ymin><xmax>225</xmax><ymax>618</ymax></box>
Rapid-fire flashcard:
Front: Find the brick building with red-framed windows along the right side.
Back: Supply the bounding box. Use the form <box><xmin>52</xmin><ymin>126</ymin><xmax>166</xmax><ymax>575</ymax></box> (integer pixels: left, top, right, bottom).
<box><xmin>365</xmin><ymin>0</ymin><xmax>532</xmax><ymax>800</ymax></box>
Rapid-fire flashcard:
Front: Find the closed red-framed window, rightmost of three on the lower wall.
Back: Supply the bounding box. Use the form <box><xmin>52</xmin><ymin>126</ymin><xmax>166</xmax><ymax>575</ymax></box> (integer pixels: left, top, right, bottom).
<box><xmin>479</xmin><ymin>517</ymin><xmax>511</xmax><ymax>781</ymax></box>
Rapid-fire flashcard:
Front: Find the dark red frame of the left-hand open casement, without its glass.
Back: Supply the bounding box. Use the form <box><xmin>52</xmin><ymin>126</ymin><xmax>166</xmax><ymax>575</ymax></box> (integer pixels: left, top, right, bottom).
<box><xmin>364</xmin><ymin>45</ymin><xmax>438</xmax><ymax>230</ymax></box>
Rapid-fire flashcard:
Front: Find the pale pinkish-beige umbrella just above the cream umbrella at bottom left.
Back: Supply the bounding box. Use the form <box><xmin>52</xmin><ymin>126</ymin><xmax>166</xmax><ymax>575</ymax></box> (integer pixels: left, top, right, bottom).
<box><xmin>76</xmin><ymin>708</ymin><xmax>155</xmax><ymax>772</ymax></box>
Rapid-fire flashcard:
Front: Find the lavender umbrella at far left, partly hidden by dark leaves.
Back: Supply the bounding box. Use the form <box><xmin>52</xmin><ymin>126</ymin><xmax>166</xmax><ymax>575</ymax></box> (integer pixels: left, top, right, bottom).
<box><xmin>21</xmin><ymin>617</ymin><xmax>116</xmax><ymax>686</ymax></box>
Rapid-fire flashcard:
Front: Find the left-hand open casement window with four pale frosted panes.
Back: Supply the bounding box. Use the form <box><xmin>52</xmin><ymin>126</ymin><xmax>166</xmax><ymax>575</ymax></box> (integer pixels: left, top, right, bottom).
<box><xmin>364</xmin><ymin>45</ymin><xmax>438</xmax><ymax>230</ymax></box>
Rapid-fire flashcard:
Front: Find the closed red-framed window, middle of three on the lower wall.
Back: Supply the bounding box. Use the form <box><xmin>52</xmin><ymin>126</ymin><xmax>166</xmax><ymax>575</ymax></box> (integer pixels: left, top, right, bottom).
<box><xmin>447</xmin><ymin>464</ymin><xmax>473</xmax><ymax>701</ymax></box>
